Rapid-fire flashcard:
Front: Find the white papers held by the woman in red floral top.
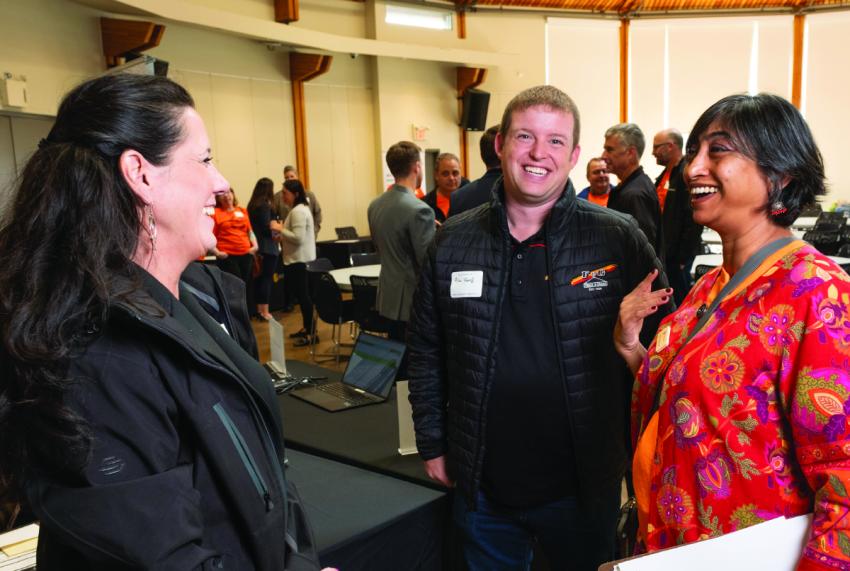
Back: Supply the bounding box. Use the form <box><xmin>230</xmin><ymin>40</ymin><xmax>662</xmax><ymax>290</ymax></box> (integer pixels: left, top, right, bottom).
<box><xmin>599</xmin><ymin>514</ymin><xmax>812</xmax><ymax>571</ymax></box>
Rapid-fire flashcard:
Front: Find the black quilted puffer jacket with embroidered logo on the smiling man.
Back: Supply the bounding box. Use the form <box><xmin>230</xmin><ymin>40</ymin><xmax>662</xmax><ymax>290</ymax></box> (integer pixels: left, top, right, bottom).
<box><xmin>408</xmin><ymin>181</ymin><xmax>670</xmax><ymax>504</ymax></box>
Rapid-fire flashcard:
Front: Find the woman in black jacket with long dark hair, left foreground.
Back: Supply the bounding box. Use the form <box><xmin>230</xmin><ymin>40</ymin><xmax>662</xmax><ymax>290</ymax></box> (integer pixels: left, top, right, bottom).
<box><xmin>0</xmin><ymin>75</ymin><xmax>318</xmax><ymax>571</ymax></box>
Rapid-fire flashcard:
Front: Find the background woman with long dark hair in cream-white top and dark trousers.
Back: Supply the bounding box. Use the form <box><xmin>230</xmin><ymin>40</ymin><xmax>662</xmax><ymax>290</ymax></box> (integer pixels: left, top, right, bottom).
<box><xmin>274</xmin><ymin>179</ymin><xmax>318</xmax><ymax>347</ymax></box>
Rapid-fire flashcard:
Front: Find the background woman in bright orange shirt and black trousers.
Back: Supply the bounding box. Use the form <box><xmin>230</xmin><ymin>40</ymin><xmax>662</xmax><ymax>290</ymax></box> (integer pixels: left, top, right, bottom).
<box><xmin>212</xmin><ymin>188</ymin><xmax>257</xmax><ymax>290</ymax></box>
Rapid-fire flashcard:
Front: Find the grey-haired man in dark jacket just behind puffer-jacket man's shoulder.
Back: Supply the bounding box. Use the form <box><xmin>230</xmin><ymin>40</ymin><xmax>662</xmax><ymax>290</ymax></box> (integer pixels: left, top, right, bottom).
<box><xmin>602</xmin><ymin>123</ymin><xmax>664</xmax><ymax>260</ymax></box>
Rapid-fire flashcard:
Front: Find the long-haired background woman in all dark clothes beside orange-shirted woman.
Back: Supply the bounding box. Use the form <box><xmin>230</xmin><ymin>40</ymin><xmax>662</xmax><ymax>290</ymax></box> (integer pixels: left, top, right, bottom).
<box><xmin>248</xmin><ymin>177</ymin><xmax>280</xmax><ymax>321</ymax></box>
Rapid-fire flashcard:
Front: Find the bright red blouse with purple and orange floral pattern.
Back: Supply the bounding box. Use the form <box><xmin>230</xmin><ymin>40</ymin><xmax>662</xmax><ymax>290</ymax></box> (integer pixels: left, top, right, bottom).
<box><xmin>632</xmin><ymin>245</ymin><xmax>850</xmax><ymax>570</ymax></box>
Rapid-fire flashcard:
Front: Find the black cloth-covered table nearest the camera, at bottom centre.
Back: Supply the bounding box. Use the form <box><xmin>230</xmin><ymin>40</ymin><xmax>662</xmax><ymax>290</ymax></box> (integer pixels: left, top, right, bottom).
<box><xmin>286</xmin><ymin>450</ymin><xmax>449</xmax><ymax>571</ymax></box>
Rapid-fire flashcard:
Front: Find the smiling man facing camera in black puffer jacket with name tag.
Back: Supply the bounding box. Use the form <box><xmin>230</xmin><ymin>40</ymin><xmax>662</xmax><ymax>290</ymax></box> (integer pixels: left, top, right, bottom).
<box><xmin>408</xmin><ymin>86</ymin><xmax>666</xmax><ymax>571</ymax></box>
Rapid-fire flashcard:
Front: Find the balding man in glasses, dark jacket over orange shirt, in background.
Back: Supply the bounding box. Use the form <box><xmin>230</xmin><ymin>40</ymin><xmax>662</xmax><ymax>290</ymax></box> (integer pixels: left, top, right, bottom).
<box><xmin>652</xmin><ymin>129</ymin><xmax>702</xmax><ymax>305</ymax></box>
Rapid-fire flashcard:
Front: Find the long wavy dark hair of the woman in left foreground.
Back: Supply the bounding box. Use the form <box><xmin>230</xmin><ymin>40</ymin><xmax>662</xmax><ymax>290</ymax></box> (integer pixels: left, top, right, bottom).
<box><xmin>0</xmin><ymin>75</ymin><xmax>193</xmax><ymax>493</ymax></box>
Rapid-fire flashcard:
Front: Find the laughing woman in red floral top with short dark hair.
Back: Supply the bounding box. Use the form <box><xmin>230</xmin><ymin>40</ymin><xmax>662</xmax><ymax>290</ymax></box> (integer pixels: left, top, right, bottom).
<box><xmin>615</xmin><ymin>94</ymin><xmax>850</xmax><ymax>570</ymax></box>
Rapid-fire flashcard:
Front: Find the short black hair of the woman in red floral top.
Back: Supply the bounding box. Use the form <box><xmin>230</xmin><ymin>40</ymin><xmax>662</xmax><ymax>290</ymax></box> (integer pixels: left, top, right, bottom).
<box><xmin>685</xmin><ymin>93</ymin><xmax>826</xmax><ymax>228</ymax></box>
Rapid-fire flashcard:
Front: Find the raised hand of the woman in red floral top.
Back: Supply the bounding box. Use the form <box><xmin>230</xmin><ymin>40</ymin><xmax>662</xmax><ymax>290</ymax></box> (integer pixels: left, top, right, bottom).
<box><xmin>614</xmin><ymin>269</ymin><xmax>673</xmax><ymax>374</ymax></box>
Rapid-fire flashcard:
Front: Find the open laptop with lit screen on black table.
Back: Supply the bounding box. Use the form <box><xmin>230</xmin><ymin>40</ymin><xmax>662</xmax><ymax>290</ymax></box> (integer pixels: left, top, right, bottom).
<box><xmin>290</xmin><ymin>333</ymin><xmax>405</xmax><ymax>412</ymax></box>
